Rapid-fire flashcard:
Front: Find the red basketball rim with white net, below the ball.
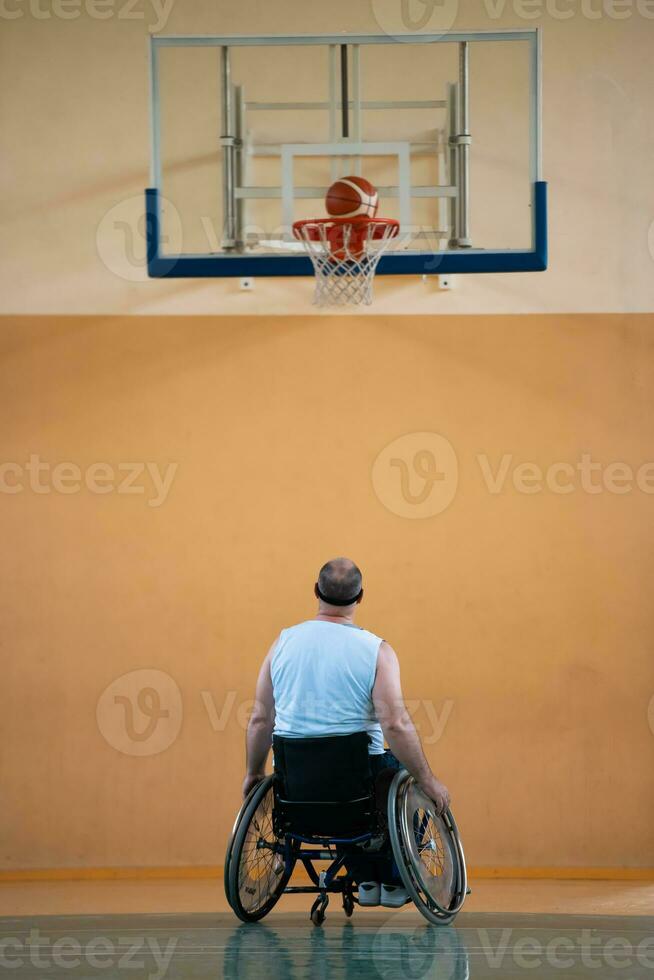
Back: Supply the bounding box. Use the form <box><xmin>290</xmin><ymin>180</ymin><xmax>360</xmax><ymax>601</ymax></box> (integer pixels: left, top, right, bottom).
<box><xmin>293</xmin><ymin>217</ymin><xmax>400</xmax><ymax>306</ymax></box>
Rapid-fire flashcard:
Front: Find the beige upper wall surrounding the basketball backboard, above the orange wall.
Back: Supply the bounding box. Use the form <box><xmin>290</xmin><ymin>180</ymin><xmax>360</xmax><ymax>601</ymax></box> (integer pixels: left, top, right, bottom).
<box><xmin>0</xmin><ymin>0</ymin><xmax>654</xmax><ymax>314</ymax></box>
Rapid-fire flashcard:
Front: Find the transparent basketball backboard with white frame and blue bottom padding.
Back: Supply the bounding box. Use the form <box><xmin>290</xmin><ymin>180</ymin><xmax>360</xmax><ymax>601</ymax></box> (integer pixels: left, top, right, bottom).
<box><xmin>146</xmin><ymin>29</ymin><xmax>547</xmax><ymax>277</ymax></box>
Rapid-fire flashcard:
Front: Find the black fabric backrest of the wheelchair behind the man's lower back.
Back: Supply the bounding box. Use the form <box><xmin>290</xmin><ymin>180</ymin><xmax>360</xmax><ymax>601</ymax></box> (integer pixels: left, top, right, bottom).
<box><xmin>273</xmin><ymin>732</ymin><xmax>377</xmax><ymax>839</ymax></box>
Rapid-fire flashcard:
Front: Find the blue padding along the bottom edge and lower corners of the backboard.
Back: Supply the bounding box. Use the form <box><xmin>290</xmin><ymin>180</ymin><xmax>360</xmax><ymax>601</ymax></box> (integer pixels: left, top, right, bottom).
<box><xmin>145</xmin><ymin>180</ymin><xmax>547</xmax><ymax>279</ymax></box>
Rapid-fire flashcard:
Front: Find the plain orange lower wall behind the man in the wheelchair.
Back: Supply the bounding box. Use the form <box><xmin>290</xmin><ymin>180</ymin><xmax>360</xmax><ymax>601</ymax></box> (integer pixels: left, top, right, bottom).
<box><xmin>0</xmin><ymin>315</ymin><xmax>654</xmax><ymax>868</ymax></box>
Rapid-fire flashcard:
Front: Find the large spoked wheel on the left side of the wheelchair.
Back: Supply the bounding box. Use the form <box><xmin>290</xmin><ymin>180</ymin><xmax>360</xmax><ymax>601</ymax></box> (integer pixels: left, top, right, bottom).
<box><xmin>225</xmin><ymin>776</ymin><xmax>295</xmax><ymax>922</ymax></box>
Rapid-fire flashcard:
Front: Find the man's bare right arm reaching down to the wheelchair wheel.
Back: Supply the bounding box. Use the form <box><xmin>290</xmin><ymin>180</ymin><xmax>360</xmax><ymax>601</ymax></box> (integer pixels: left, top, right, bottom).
<box><xmin>372</xmin><ymin>642</ymin><xmax>450</xmax><ymax>813</ymax></box>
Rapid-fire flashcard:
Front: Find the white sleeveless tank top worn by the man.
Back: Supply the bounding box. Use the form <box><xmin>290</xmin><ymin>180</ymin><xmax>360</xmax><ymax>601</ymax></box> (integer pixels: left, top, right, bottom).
<box><xmin>270</xmin><ymin>619</ymin><xmax>384</xmax><ymax>755</ymax></box>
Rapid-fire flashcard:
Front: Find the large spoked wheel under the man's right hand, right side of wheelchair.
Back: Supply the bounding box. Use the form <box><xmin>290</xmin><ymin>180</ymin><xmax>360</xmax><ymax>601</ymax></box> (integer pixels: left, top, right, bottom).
<box><xmin>388</xmin><ymin>769</ymin><xmax>467</xmax><ymax>925</ymax></box>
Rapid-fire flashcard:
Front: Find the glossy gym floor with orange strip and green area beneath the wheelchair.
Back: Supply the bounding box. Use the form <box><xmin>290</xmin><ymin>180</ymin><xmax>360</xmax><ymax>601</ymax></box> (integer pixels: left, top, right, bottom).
<box><xmin>0</xmin><ymin>881</ymin><xmax>654</xmax><ymax>980</ymax></box>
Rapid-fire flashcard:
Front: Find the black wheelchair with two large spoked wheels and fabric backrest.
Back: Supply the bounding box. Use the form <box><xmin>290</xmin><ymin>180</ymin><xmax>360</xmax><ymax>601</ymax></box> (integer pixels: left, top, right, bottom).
<box><xmin>224</xmin><ymin>732</ymin><xmax>469</xmax><ymax>926</ymax></box>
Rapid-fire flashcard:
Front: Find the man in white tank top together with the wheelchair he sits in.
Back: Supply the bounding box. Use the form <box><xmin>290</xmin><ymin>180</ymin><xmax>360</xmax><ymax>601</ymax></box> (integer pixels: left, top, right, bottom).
<box><xmin>225</xmin><ymin>558</ymin><xmax>465</xmax><ymax>924</ymax></box>
